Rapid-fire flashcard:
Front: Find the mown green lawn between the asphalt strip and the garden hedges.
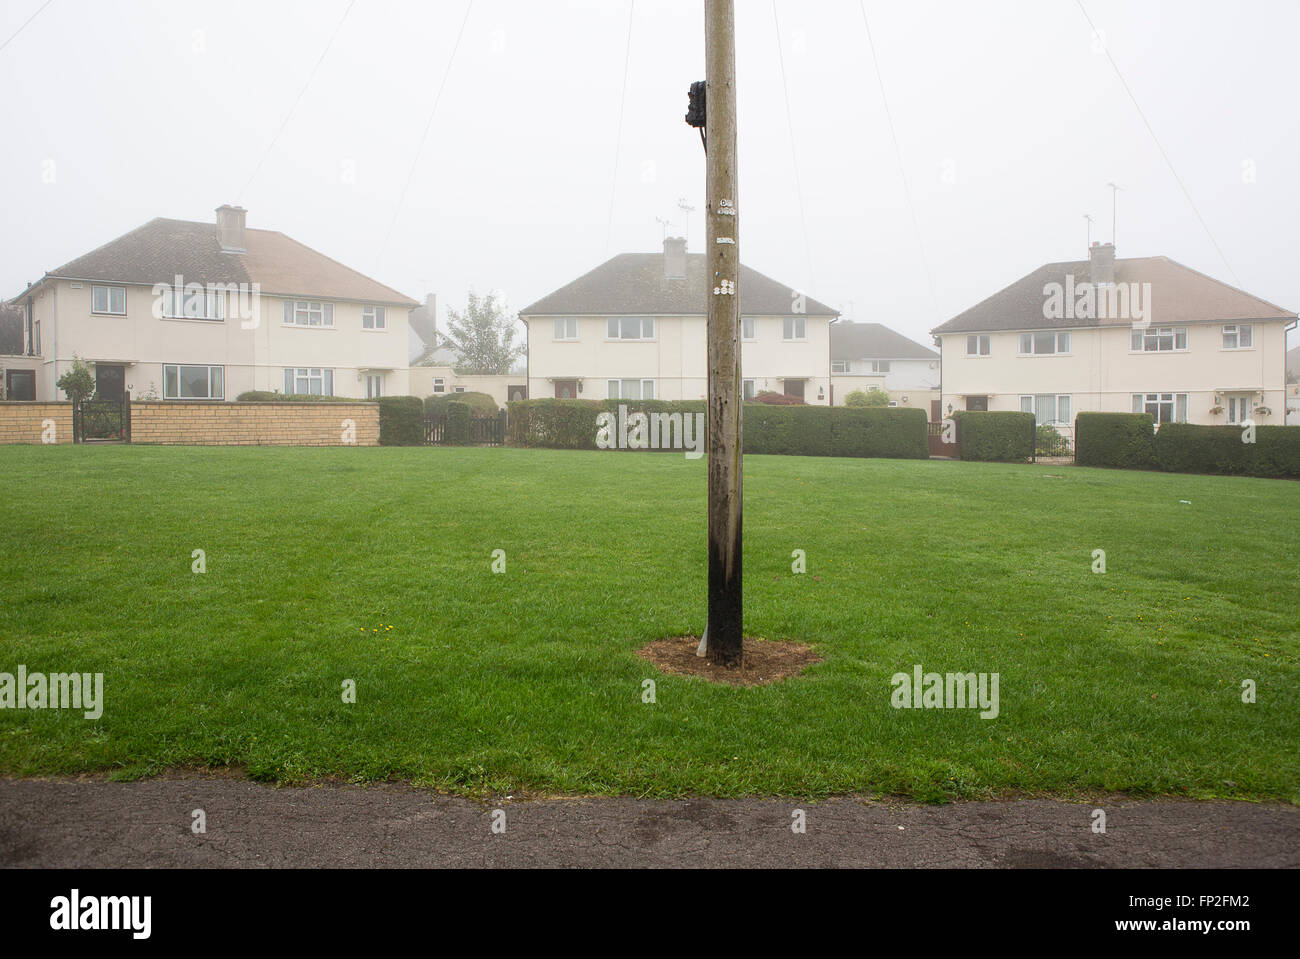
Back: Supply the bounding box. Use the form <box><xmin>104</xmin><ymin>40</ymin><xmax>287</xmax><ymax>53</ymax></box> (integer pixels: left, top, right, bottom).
<box><xmin>0</xmin><ymin>447</ymin><xmax>1300</xmax><ymax>803</ymax></box>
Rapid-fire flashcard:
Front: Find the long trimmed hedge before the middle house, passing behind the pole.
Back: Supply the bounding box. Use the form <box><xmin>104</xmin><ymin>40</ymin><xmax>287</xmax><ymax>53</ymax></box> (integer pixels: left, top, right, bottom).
<box><xmin>506</xmin><ymin>399</ymin><xmax>930</xmax><ymax>460</ymax></box>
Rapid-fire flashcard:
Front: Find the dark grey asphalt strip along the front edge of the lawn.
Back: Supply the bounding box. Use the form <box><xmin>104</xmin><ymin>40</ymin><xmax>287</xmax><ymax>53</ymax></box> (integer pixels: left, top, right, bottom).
<box><xmin>0</xmin><ymin>777</ymin><xmax>1300</xmax><ymax>868</ymax></box>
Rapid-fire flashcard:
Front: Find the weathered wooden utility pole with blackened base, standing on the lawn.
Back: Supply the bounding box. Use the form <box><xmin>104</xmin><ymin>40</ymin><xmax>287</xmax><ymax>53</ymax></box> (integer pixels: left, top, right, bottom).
<box><xmin>705</xmin><ymin>0</ymin><xmax>744</xmax><ymax>667</ymax></box>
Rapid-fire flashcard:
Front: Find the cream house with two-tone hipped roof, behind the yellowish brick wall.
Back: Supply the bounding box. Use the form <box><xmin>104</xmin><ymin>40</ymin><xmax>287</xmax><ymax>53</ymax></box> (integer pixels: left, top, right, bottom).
<box><xmin>5</xmin><ymin>205</ymin><xmax>417</xmax><ymax>402</ymax></box>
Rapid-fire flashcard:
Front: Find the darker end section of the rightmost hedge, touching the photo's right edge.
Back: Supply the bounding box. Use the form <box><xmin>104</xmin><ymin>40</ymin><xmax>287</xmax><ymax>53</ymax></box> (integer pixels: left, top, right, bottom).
<box><xmin>1153</xmin><ymin>422</ymin><xmax>1300</xmax><ymax>480</ymax></box>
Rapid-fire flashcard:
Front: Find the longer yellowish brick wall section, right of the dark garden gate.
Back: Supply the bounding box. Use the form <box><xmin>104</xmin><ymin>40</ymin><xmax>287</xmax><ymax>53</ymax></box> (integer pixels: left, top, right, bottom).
<box><xmin>132</xmin><ymin>402</ymin><xmax>380</xmax><ymax>446</ymax></box>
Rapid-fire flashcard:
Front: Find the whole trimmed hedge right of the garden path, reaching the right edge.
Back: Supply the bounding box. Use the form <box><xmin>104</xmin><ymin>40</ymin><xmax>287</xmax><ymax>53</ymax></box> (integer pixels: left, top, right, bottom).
<box><xmin>1075</xmin><ymin>413</ymin><xmax>1300</xmax><ymax>480</ymax></box>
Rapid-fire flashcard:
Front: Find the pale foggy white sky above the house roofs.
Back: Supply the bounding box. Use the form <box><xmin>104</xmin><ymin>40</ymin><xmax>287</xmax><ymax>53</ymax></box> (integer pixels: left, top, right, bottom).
<box><xmin>0</xmin><ymin>0</ymin><xmax>1300</xmax><ymax>346</ymax></box>
